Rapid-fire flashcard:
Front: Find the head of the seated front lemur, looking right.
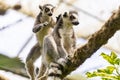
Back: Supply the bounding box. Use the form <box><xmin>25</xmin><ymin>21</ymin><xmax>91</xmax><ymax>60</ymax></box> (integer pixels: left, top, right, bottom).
<box><xmin>63</xmin><ymin>11</ymin><xmax>79</xmax><ymax>25</ymax></box>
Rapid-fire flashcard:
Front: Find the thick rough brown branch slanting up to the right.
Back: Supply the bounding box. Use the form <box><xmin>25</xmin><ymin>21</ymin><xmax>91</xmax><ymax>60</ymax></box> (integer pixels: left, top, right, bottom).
<box><xmin>60</xmin><ymin>8</ymin><xmax>120</xmax><ymax>78</ymax></box>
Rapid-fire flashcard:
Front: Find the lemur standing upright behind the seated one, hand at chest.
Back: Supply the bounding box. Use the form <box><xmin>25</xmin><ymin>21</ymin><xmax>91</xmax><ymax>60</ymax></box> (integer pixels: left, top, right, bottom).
<box><xmin>26</xmin><ymin>4</ymin><xmax>55</xmax><ymax>80</ymax></box>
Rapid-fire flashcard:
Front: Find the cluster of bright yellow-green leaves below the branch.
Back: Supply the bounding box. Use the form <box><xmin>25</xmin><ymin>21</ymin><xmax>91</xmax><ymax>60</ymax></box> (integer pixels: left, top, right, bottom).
<box><xmin>86</xmin><ymin>52</ymin><xmax>120</xmax><ymax>80</ymax></box>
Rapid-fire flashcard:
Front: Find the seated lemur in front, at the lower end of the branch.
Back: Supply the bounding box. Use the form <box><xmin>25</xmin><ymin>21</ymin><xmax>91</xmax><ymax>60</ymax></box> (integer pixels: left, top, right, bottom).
<box><xmin>38</xmin><ymin>11</ymin><xmax>79</xmax><ymax>80</ymax></box>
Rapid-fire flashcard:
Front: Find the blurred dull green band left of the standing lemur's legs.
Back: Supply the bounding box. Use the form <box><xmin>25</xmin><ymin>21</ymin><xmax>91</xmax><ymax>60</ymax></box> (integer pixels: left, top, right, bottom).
<box><xmin>0</xmin><ymin>54</ymin><xmax>28</xmax><ymax>77</ymax></box>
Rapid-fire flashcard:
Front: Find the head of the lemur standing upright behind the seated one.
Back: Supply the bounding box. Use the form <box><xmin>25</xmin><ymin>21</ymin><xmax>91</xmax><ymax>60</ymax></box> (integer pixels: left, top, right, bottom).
<box><xmin>39</xmin><ymin>4</ymin><xmax>55</xmax><ymax>16</ymax></box>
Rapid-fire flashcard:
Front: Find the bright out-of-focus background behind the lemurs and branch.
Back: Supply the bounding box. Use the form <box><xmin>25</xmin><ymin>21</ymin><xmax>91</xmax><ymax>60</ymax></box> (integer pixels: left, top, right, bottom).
<box><xmin>0</xmin><ymin>0</ymin><xmax>120</xmax><ymax>80</ymax></box>
